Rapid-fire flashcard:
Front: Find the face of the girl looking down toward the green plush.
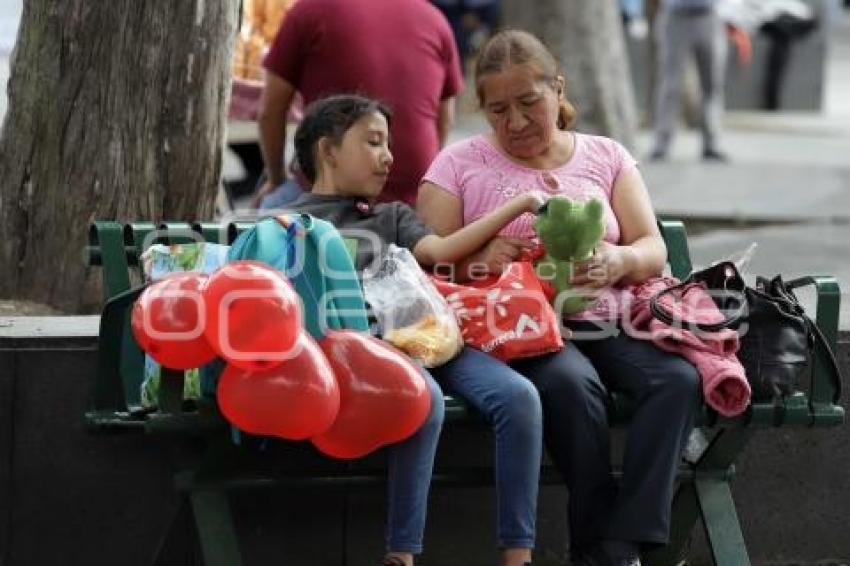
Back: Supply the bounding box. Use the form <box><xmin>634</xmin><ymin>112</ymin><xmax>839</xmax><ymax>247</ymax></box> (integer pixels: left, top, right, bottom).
<box><xmin>329</xmin><ymin>112</ymin><xmax>393</xmax><ymax>198</ymax></box>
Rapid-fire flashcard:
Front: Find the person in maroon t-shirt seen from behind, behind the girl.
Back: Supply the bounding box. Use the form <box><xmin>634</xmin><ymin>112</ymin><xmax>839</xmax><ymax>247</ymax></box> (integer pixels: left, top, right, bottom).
<box><xmin>255</xmin><ymin>0</ymin><xmax>463</xmax><ymax>209</ymax></box>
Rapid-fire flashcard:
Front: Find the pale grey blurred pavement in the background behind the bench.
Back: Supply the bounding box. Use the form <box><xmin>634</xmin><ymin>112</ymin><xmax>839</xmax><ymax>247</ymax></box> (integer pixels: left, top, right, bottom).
<box><xmin>0</xmin><ymin>6</ymin><xmax>850</xmax><ymax>329</ymax></box>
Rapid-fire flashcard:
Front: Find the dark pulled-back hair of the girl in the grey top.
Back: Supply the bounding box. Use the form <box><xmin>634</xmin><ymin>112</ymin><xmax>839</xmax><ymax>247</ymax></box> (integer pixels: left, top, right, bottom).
<box><xmin>295</xmin><ymin>94</ymin><xmax>392</xmax><ymax>183</ymax></box>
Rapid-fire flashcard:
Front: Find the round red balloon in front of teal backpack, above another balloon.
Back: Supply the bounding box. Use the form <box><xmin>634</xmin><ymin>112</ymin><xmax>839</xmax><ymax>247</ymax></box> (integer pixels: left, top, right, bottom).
<box><xmin>204</xmin><ymin>260</ymin><xmax>302</xmax><ymax>370</ymax></box>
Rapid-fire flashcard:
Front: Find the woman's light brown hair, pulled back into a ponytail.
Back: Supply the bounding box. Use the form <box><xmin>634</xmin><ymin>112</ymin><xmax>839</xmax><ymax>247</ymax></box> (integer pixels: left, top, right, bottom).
<box><xmin>475</xmin><ymin>29</ymin><xmax>576</xmax><ymax>130</ymax></box>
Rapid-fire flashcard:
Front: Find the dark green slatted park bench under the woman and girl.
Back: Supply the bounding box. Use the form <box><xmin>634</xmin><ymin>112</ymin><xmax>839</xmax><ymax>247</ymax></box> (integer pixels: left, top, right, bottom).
<box><xmin>85</xmin><ymin>221</ymin><xmax>844</xmax><ymax>566</ymax></box>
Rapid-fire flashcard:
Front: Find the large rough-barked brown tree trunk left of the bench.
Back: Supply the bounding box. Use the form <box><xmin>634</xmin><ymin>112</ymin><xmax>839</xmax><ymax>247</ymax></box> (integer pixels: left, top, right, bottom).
<box><xmin>0</xmin><ymin>0</ymin><xmax>239</xmax><ymax>312</ymax></box>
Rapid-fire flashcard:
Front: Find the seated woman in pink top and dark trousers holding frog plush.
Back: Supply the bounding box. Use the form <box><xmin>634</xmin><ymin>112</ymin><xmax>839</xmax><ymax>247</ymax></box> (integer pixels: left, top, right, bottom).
<box><xmin>418</xmin><ymin>30</ymin><xmax>699</xmax><ymax>565</ymax></box>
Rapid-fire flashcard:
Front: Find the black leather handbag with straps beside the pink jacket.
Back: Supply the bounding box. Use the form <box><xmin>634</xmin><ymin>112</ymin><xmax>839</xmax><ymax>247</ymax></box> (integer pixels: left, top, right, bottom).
<box><xmin>650</xmin><ymin>261</ymin><xmax>841</xmax><ymax>403</ymax></box>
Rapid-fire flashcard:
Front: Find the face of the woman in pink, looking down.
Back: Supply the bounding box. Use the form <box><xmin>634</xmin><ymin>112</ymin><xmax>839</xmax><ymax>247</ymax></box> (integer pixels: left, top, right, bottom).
<box><xmin>480</xmin><ymin>65</ymin><xmax>564</xmax><ymax>158</ymax></box>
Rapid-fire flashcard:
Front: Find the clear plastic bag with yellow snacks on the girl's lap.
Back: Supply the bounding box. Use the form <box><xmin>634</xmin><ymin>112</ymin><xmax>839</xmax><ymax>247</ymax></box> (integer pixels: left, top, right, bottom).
<box><xmin>363</xmin><ymin>244</ymin><xmax>463</xmax><ymax>367</ymax></box>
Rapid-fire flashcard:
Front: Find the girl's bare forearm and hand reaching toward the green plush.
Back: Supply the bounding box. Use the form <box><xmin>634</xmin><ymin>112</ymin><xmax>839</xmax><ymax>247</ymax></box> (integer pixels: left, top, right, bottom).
<box><xmin>413</xmin><ymin>188</ymin><xmax>545</xmax><ymax>266</ymax></box>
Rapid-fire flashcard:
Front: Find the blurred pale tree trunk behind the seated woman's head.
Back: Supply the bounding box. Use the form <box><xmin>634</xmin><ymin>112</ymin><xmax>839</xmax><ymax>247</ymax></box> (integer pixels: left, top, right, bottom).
<box><xmin>502</xmin><ymin>0</ymin><xmax>637</xmax><ymax>149</ymax></box>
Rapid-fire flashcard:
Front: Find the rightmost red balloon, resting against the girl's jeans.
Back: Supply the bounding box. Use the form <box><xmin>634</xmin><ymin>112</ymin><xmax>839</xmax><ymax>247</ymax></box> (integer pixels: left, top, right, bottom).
<box><xmin>310</xmin><ymin>330</ymin><xmax>431</xmax><ymax>458</ymax></box>
